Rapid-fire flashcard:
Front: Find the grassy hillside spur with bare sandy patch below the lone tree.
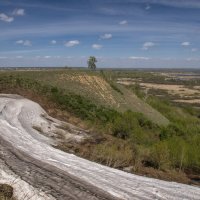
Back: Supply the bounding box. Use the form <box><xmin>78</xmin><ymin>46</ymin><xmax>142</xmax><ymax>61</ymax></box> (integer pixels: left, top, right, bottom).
<box><xmin>0</xmin><ymin>70</ymin><xmax>169</xmax><ymax>125</ymax></box>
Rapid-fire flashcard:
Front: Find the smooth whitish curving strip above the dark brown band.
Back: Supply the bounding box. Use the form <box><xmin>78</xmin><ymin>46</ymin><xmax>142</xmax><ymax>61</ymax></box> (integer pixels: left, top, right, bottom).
<box><xmin>0</xmin><ymin>95</ymin><xmax>200</xmax><ymax>200</ymax></box>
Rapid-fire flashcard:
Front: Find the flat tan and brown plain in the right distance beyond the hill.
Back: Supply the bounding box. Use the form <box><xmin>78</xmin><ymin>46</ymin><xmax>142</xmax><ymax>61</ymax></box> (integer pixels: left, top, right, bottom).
<box><xmin>117</xmin><ymin>72</ymin><xmax>200</xmax><ymax>104</ymax></box>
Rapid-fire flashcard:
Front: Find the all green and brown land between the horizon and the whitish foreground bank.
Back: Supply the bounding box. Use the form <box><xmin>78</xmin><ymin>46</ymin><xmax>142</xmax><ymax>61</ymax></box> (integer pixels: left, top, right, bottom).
<box><xmin>0</xmin><ymin>69</ymin><xmax>200</xmax><ymax>184</ymax></box>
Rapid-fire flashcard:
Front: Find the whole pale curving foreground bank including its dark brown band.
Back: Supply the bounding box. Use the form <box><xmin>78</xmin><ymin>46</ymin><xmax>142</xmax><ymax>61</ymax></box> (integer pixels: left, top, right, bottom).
<box><xmin>0</xmin><ymin>95</ymin><xmax>200</xmax><ymax>200</ymax></box>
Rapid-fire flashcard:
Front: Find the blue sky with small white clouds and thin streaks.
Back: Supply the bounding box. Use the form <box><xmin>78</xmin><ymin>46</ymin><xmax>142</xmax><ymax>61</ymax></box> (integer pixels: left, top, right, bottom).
<box><xmin>0</xmin><ymin>0</ymin><xmax>200</xmax><ymax>68</ymax></box>
